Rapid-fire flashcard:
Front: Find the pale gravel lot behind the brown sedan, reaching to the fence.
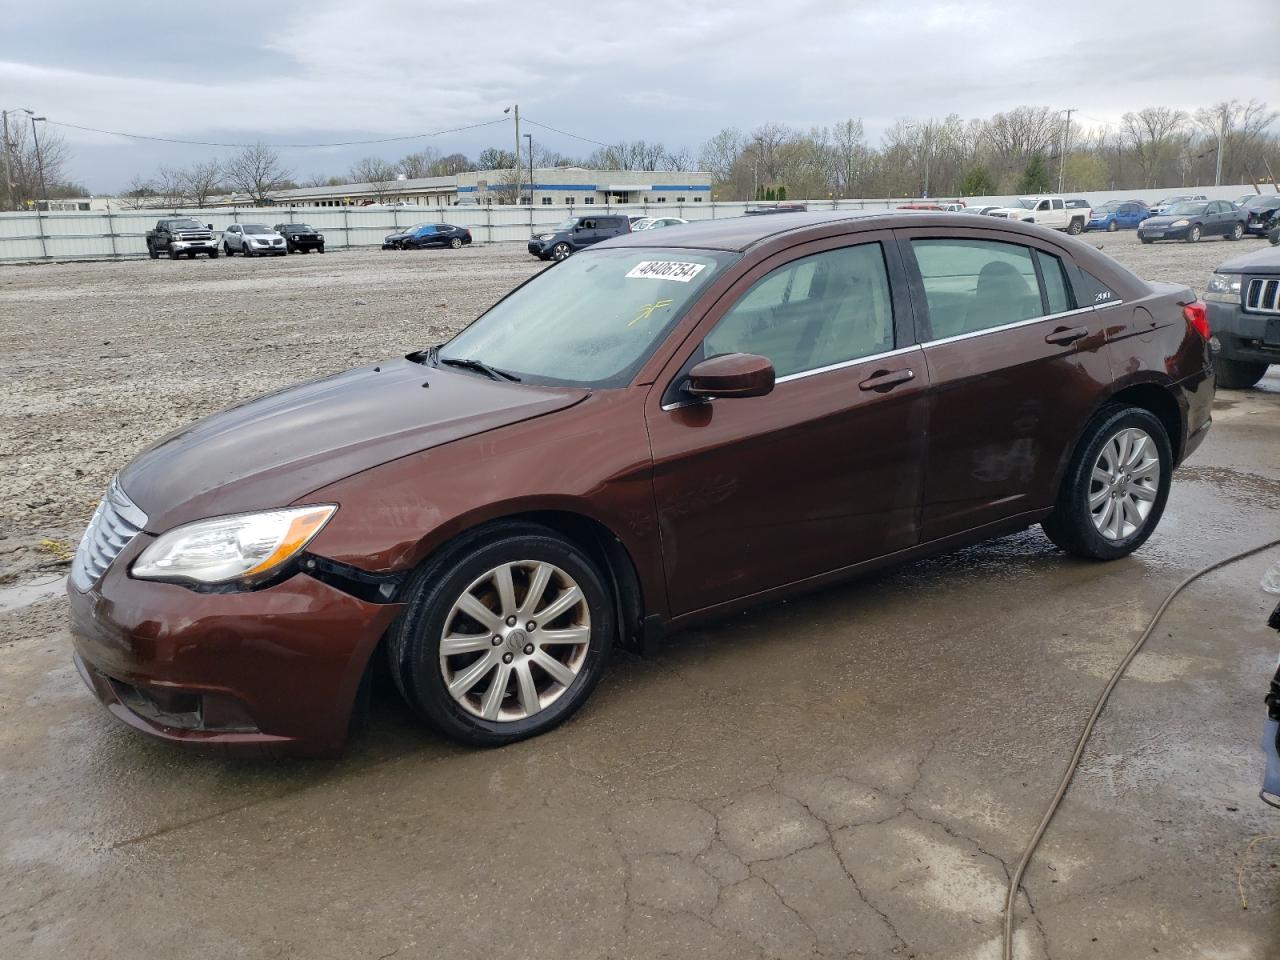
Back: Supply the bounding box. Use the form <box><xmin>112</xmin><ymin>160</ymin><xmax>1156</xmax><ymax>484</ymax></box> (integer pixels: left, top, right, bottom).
<box><xmin>0</xmin><ymin>232</ymin><xmax>1263</xmax><ymax>582</ymax></box>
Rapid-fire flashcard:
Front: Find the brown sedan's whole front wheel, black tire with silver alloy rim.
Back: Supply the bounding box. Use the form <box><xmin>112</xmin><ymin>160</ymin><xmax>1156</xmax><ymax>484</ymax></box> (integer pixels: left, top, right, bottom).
<box><xmin>387</xmin><ymin>524</ymin><xmax>616</xmax><ymax>746</ymax></box>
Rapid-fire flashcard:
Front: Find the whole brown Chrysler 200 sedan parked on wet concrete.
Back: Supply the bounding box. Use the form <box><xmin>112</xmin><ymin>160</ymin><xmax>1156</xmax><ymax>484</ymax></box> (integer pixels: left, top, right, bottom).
<box><xmin>69</xmin><ymin>212</ymin><xmax>1213</xmax><ymax>753</ymax></box>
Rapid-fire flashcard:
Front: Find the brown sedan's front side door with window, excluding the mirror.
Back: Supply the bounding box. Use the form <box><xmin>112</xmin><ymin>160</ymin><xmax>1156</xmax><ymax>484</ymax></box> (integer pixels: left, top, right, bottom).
<box><xmin>646</xmin><ymin>232</ymin><xmax>928</xmax><ymax>616</ymax></box>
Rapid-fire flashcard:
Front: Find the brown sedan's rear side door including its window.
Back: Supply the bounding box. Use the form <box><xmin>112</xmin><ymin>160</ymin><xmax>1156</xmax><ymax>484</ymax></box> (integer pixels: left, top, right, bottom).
<box><xmin>897</xmin><ymin>228</ymin><xmax>1111</xmax><ymax>541</ymax></box>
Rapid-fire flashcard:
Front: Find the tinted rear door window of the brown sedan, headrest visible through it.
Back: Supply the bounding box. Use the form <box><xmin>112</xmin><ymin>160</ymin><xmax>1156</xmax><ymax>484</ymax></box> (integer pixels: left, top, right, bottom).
<box><xmin>911</xmin><ymin>237</ymin><xmax>1044</xmax><ymax>340</ymax></box>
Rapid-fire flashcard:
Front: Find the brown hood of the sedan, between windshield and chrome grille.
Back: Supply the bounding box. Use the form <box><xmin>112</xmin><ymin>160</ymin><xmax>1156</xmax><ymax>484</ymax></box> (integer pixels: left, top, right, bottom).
<box><xmin>119</xmin><ymin>360</ymin><xmax>590</xmax><ymax>532</ymax></box>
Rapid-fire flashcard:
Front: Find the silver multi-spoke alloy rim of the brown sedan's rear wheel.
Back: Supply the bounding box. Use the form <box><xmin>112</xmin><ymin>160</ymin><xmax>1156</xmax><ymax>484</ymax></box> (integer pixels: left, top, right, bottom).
<box><xmin>1089</xmin><ymin>426</ymin><xmax>1160</xmax><ymax>541</ymax></box>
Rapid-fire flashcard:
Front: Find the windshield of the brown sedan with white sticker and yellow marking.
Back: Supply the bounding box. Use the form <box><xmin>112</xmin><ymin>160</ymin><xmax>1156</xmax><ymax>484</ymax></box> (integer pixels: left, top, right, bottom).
<box><xmin>440</xmin><ymin>247</ymin><xmax>739</xmax><ymax>388</ymax></box>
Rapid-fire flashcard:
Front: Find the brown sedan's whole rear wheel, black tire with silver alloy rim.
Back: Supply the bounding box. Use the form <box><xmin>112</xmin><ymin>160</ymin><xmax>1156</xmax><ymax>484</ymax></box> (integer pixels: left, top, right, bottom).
<box><xmin>1041</xmin><ymin>404</ymin><xmax>1174</xmax><ymax>559</ymax></box>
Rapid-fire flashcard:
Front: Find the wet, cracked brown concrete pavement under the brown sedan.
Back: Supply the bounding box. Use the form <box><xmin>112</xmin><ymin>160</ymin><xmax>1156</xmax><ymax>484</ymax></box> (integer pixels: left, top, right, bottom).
<box><xmin>0</xmin><ymin>374</ymin><xmax>1280</xmax><ymax>960</ymax></box>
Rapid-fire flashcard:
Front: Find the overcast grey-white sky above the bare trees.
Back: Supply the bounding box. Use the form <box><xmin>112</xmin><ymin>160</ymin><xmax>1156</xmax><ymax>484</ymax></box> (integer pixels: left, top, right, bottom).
<box><xmin>0</xmin><ymin>0</ymin><xmax>1280</xmax><ymax>192</ymax></box>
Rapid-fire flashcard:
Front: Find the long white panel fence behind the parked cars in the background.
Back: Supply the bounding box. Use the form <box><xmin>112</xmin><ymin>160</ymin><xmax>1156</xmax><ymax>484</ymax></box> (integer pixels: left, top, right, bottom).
<box><xmin>0</xmin><ymin>184</ymin><xmax>1253</xmax><ymax>264</ymax></box>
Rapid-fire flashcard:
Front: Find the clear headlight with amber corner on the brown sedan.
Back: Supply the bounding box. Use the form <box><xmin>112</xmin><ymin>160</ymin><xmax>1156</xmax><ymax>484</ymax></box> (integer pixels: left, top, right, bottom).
<box><xmin>131</xmin><ymin>503</ymin><xmax>338</xmax><ymax>584</ymax></box>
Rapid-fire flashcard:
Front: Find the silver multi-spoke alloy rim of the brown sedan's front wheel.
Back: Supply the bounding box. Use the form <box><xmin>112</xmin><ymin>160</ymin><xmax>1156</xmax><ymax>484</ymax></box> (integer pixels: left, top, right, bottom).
<box><xmin>439</xmin><ymin>561</ymin><xmax>591</xmax><ymax>723</ymax></box>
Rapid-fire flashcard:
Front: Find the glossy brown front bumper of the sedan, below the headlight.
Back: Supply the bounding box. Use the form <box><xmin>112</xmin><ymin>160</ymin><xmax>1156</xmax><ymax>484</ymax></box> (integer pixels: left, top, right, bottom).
<box><xmin>68</xmin><ymin>534</ymin><xmax>403</xmax><ymax>755</ymax></box>
